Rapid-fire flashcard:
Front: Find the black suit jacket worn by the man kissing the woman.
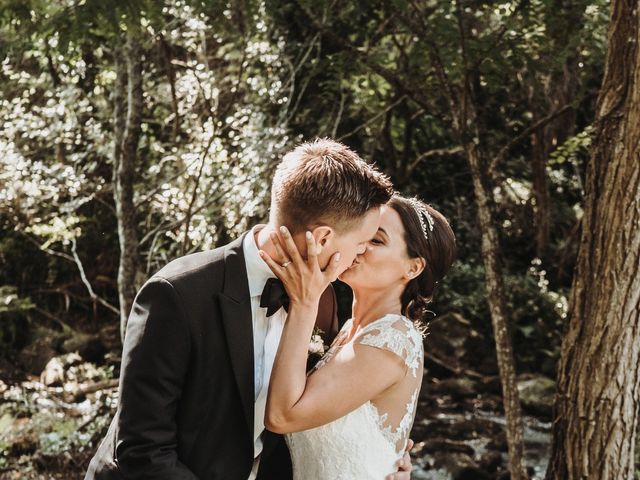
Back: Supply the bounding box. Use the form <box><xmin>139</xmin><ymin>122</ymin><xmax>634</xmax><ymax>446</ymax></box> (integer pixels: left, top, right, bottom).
<box><xmin>85</xmin><ymin>234</ymin><xmax>338</xmax><ymax>480</ymax></box>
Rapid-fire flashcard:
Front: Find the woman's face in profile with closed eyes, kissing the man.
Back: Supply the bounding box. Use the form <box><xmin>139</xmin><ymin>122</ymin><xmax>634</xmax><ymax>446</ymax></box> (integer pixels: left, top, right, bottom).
<box><xmin>339</xmin><ymin>206</ymin><xmax>417</xmax><ymax>289</ymax></box>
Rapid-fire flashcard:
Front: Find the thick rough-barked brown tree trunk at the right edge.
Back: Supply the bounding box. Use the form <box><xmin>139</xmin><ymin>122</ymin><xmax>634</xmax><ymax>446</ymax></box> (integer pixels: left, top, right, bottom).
<box><xmin>546</xmin><ymin>0</ymin><xmax>640</xmax><ymax>480</ymax></box>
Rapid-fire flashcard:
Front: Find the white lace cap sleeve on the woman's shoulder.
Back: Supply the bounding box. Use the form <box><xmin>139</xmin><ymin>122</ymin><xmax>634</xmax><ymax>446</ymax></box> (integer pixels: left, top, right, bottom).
<box><xmin>355</xmin><ymin>315</ymin><xmax>423</xmax><ymax>377</ymax></box>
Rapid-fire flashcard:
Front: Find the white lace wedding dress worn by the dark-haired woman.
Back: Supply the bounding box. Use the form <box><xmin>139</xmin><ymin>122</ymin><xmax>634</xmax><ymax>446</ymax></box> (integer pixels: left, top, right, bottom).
<box><xmin>285</xmin><ymin>315</ymin><xmax>424</xmax><ymax>480</ymax></box>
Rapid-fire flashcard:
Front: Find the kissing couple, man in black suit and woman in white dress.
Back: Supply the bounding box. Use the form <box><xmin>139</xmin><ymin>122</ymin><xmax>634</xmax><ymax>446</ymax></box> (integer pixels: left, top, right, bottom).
<box><xmin>85</xmin><ymin>139</ymin><xmax>455</xmax><ymax>480</ymax></box>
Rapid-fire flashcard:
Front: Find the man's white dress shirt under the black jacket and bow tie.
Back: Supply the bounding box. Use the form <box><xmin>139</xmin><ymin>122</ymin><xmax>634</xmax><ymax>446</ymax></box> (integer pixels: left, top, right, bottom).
<box><xmin>242</xmin><ymin>225</ymin><xmax>287</xmax><ymax>480</ymax></box>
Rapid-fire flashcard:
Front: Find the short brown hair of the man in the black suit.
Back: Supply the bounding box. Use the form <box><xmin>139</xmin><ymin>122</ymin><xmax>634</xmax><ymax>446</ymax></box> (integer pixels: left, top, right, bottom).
<box><xmin>271</xmin><ymin>138</ymin><xmax>393</xmax><ymax>233</ymax></box>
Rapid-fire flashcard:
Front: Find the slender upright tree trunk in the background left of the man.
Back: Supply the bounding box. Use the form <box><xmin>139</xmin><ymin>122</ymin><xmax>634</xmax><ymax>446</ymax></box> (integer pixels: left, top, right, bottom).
<box><xmin>113</xmin><ymin>33</ymin><xmax>142</xmax><ymax>340</ymax></box>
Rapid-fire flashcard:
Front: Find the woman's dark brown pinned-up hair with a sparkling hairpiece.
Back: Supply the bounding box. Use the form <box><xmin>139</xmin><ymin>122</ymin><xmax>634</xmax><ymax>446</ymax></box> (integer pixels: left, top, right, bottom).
<box><xmin>387</xmin><ymin>194</ymin><xmax>456</xmax><ymax>320</ymax></box>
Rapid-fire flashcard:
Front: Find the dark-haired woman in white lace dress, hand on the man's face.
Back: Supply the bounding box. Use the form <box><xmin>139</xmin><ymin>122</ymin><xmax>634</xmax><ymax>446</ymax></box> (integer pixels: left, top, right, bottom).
<box><xmin>260</xmin><ymin>195</ymin><xmax>455</xmax><ymax>480</ymax></box>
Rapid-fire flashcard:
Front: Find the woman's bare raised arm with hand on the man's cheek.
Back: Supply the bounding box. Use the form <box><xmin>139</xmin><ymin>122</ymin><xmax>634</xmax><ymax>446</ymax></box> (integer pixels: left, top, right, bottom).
<box><xmin>263</xmin><ymin>227</ymin><xmax>406</xmax><ymax>433</ymax></box>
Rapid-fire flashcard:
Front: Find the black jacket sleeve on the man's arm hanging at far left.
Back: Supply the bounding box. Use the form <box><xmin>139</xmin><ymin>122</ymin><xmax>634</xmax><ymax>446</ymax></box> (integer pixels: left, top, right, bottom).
<box><xmin>115</xmin><ymin>277</ymin><xmax>197</xmax><ymax>480</ymax></box>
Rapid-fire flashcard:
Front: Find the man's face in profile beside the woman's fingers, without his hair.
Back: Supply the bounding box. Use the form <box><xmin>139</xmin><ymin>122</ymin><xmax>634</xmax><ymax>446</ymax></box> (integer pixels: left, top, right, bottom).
<box><xmin>318</xmin><ymin>208</ymin><xmax>380</xmax><ymax>274</ymax></box>
